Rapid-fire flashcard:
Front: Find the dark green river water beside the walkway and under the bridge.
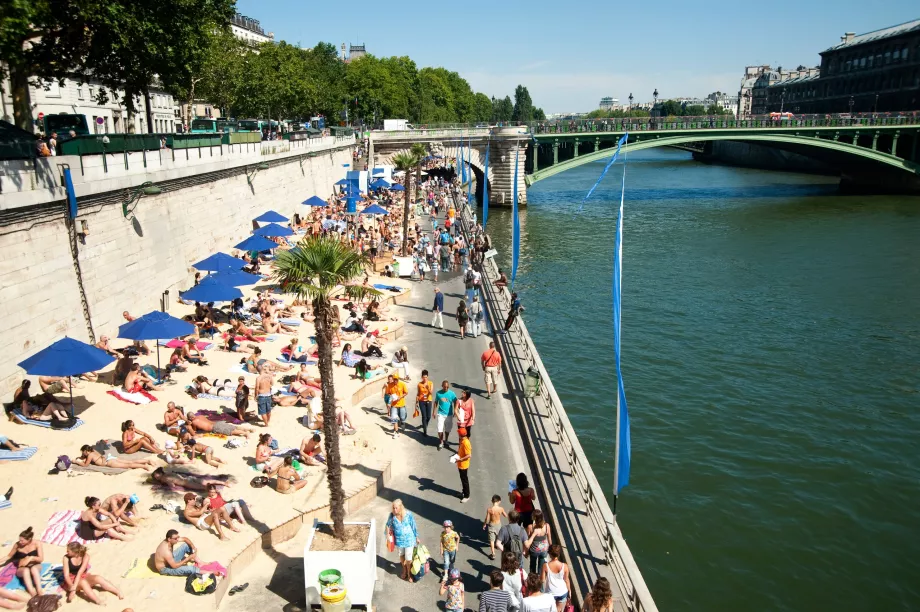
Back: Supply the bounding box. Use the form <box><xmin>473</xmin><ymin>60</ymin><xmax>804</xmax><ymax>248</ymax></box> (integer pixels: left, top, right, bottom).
<box><xmin>488</xmin><ymin>150</ymin><xmax>920</xmax><ymax>611</ymax></box>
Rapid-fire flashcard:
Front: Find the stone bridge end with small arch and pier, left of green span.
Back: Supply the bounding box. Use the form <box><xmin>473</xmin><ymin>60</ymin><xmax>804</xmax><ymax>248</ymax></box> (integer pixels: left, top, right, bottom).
<box><xmin>368</xmin><ymin>127</ymin><xmax>532</xmax><ymax>207</ymax></box>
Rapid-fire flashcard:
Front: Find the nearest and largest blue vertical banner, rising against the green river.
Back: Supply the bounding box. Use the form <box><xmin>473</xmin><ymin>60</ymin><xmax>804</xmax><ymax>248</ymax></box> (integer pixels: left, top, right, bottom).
<box><xmin>613</xmin><ymin>148</ymin><xmax>632</xmax><ymax>498</ymax></box>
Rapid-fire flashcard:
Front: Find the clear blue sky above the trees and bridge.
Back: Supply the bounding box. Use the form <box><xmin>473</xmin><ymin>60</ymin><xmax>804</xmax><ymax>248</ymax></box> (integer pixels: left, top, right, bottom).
<box><xmin>237</xmin><ymin>0</ymin><xmax>920</xmax><ymax>113</ymax></box>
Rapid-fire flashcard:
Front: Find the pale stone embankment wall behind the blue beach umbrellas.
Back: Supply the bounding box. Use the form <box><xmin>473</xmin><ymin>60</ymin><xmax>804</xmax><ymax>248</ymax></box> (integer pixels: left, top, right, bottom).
<box><xmin>0</xmin><ymin>143</ymin><xmax>353</xmax><ymax>401</ymax></box>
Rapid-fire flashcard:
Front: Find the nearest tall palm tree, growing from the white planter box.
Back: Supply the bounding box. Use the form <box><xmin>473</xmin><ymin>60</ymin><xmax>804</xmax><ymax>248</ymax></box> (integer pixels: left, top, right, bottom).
<box><xmin>274</xmin><ymin>236</ymin><xmax>380</xmax><ymax>539</ymax></box>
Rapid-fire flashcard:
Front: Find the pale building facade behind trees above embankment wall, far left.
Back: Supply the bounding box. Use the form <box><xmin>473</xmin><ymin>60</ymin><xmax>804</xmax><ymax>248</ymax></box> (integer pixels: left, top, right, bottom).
<box><xmin>0</xmin><ymin>71</ymin><xmax>182</xmax><ymax>134</ymax></box>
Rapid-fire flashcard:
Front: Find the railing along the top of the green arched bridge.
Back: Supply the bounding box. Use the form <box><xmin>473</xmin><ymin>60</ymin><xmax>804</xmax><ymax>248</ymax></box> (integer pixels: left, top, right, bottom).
<box><xmin>529</xmin><ymin>112</ymin><xmax>920</xmax><ymax>135</ymax></box>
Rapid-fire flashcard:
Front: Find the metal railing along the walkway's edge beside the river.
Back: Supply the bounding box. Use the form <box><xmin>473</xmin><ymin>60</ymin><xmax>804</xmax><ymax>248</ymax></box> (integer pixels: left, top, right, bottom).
<box><xmin>452</xmin><ymin>190</ymin><xmax>658</xmax><ymax>612</ymax></box>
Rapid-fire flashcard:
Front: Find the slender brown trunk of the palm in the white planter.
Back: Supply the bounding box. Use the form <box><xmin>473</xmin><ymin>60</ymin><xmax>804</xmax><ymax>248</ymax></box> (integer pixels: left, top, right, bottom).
<box><xmin>313</xmin><ymin>298</ymin><xmax>345</xmax><ymax>540</ymax></box>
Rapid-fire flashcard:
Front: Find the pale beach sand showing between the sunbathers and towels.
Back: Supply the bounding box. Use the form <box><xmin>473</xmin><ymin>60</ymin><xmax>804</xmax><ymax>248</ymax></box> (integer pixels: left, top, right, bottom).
<box><xmin>0</xmin><ymin>260</ymin><xmax>417</xmax><ymax>612</ymax></box>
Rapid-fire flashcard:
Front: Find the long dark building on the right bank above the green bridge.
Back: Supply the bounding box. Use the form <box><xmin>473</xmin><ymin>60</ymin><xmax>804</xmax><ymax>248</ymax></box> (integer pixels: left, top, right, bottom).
<box><xmin>754</xmin><ymin>19</ymin><xmax>920</xmax><ymax>114</ymax></box>
